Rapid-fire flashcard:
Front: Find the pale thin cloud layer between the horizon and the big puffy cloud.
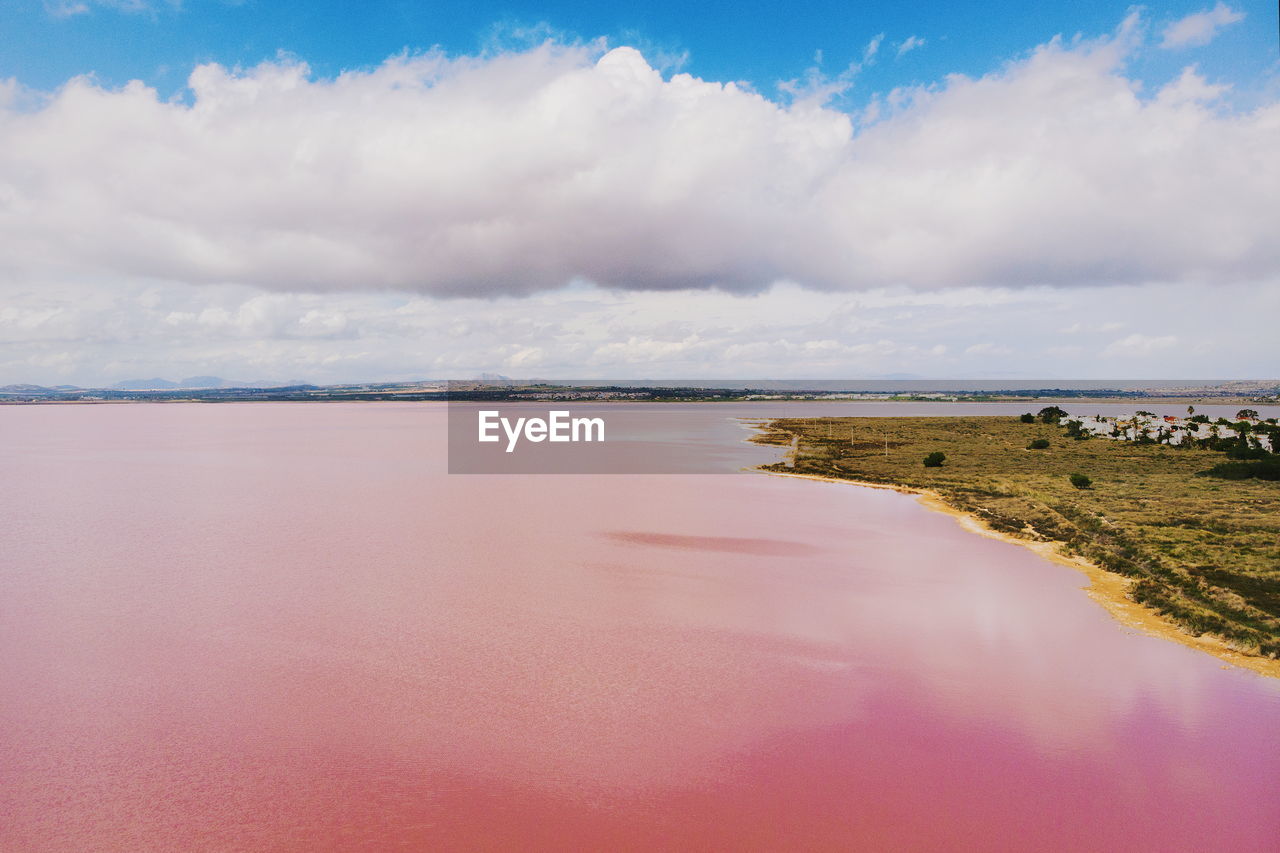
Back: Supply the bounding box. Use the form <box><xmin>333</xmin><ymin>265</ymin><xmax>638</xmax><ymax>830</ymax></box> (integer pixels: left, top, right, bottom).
<box><xmin>0</xmin><ymin>278</ymin><xmax>1280</xmax><ymax>384</ymax></box>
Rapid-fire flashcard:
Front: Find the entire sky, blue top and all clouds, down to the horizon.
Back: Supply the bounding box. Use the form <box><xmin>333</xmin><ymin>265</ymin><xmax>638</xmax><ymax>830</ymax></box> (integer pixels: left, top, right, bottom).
<box><xmin>0</xmin><ymin>0</ymin><xmax>1280</xmax><ymax>384</ymax></box>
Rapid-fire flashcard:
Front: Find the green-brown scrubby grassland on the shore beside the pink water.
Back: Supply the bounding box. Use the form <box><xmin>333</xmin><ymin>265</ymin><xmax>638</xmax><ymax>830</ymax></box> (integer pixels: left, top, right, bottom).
<box><xmin>758</xmin><ymin>416</ymin><xmax>1280</xmax><ymax>658</ymax></box>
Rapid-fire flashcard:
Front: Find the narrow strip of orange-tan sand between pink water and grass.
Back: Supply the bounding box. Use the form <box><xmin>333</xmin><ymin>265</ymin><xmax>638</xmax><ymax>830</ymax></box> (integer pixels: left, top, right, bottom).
<box><xmin>755</xmin><ymin>469</ymin><xmax>1280</xmax><ymax>679</ymax></box>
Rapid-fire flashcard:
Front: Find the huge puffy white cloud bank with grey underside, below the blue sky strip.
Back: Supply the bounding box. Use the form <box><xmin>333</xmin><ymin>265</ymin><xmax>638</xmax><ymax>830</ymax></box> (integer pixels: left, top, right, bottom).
<box><xmin>0</xmin><ymin>10</ymin><xmax>1280</xmax><ymax>297</ymax></box>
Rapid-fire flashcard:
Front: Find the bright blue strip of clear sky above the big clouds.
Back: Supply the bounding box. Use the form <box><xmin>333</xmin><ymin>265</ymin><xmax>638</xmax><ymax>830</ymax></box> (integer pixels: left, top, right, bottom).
<box><xmin>10</xmin><ymin>0</ymin><xmax>1277</xmax><ymax>103</ymax></box>
